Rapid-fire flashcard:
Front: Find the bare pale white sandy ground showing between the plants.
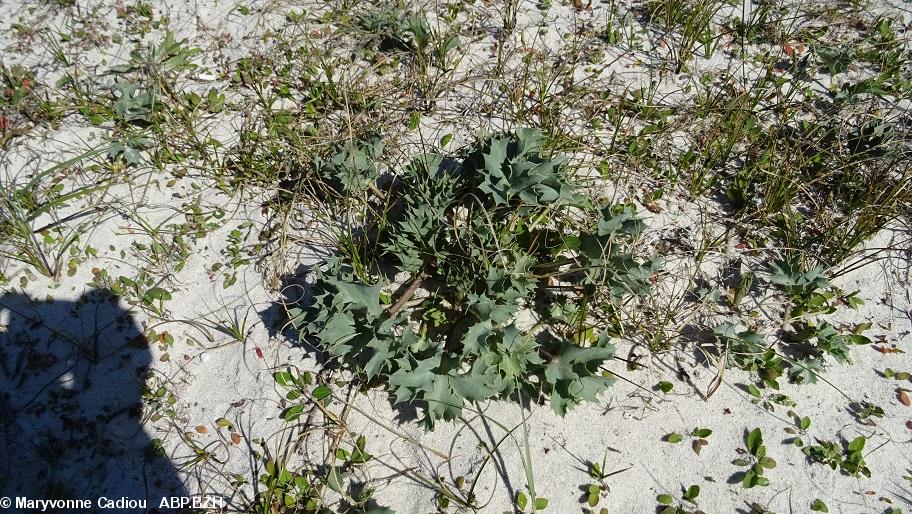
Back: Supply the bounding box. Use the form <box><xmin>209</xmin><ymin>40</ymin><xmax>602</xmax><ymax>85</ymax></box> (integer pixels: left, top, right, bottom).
<box><xmin>0</xmin><ymin>0</ymin><xmax>912</xmax><ymax>514</ymax></box>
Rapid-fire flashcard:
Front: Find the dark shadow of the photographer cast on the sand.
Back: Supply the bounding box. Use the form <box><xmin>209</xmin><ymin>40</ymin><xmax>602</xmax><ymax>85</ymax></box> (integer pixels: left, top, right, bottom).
<box><xmin>0</xmin><ymin>289</ymin><xmax>187</xmax><ymax>512</ymax></box>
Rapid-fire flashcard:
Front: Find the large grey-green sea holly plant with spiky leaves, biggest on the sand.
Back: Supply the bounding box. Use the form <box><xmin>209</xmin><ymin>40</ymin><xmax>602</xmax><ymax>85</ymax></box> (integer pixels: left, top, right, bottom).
<box><xmin>289</xmin><ymin>129</ymin><xmax>659</xmax><ymax>428</ymax></box>
